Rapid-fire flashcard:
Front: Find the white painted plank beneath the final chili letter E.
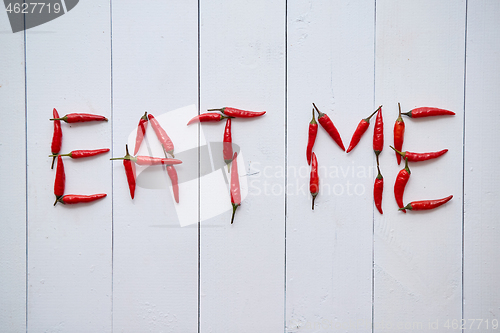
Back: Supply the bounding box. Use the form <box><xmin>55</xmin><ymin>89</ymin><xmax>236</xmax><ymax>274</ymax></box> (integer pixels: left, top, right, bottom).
<box><xmin>374</xmin><ymin>0</ymin><xmax>465</xmax><ymax>332</ymax></box>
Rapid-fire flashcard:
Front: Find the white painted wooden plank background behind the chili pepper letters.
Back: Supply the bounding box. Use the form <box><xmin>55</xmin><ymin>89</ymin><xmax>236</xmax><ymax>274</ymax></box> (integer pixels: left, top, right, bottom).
<box><xmin>0</xmin><ymin>0</ymin><xmax>500</xmax><ymax>333</ymax></box>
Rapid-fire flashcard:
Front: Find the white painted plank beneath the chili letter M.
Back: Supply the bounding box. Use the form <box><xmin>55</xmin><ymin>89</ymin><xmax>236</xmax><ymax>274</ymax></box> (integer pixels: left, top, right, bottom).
<box><xmin>286</xmin><ymin>1</ymin><xmax>378</xmax><ymax>332</ymax></box>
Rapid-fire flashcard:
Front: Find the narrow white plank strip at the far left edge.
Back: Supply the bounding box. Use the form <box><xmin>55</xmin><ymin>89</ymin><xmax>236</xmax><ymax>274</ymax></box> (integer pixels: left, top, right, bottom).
<box><xmin>0</xmin><ymin>15</ymin><xmax>26</xmax><ymax>332</ymax></box>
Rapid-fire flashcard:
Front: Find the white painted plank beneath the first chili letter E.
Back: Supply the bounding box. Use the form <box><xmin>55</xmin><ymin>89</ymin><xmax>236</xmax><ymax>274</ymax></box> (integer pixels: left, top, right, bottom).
<box><xmin>26</xmin><ymin>1</ymin><xmax>112</xmax><ymax>332</ymax></box>
